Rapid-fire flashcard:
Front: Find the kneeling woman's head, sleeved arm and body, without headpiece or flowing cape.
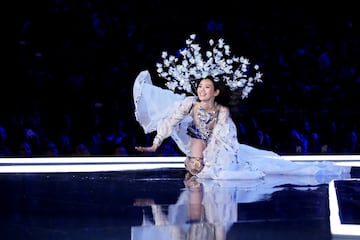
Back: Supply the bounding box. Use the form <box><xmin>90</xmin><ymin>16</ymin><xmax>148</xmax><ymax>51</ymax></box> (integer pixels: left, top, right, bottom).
<box><xmin>135</xmin><ymin>76</ymin><xmax>229</xmax><ymax>175</ymax></box>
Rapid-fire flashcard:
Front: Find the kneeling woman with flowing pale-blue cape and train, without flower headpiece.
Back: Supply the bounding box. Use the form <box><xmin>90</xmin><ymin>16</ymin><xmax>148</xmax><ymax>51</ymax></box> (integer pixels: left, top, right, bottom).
<box><xmin>134</xmin><ymin>71</ymin><xmax>350</xmax><ymax>179</ymax></box>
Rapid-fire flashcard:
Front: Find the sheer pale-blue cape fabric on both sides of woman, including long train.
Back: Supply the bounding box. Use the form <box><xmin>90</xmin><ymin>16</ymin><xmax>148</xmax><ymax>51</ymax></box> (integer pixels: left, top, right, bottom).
<box><xmin>133</xmin><ymin>71</ymin><xmax>351</xmax><ymax>179</ymax></box>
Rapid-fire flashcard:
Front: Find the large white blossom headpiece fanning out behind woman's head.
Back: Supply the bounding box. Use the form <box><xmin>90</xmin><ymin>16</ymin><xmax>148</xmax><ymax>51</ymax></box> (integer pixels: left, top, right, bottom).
<box><xmin>156</xmin><ymin>34</ymin><xmax>262</xmax><ymax>99</ymax></box>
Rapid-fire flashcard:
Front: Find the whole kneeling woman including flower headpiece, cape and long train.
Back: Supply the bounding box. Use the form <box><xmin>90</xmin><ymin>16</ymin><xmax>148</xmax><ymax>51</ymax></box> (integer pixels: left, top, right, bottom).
<box><xmin>133</xmin><ymin>36</ymin><xmax>350</xmax><ymax>179</ymax></box>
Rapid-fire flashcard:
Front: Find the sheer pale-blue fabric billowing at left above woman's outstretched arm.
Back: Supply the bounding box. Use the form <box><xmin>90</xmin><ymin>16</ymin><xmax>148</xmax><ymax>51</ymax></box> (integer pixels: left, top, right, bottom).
<box><xmin>133</xmin><ymin>71</ymin><xmax>195</xmax><ymax>155</ymax></box>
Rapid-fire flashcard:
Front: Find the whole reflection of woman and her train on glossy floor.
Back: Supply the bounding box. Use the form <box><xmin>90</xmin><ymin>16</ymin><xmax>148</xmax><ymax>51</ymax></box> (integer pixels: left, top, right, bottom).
<box><xmin>132</xmin><ymin>176</ymin><xmax>331</xmax><ymax>240</ymax></box>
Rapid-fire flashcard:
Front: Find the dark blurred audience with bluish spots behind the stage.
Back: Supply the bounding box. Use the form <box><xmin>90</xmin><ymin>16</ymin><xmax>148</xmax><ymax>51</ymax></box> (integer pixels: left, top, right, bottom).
<box><xmin>0</xmin><ymin>0</ymin><xmax>360</xmax><ymax>157</ymax></box>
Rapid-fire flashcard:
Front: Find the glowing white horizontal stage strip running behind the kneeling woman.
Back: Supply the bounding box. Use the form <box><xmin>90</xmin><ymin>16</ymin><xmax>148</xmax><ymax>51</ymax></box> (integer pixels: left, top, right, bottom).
<box><xmin>0</xmin><ymin>155</ymin><xmax>360</xmax><ymax>173</ymax></box>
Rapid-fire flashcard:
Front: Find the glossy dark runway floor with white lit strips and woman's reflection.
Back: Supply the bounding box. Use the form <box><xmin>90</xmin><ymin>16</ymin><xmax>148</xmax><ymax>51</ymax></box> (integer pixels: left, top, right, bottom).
<box><xmin>0</xmin><ymin>158</ymin><xmax>360</xmax><ymax>240</ymax></box>
